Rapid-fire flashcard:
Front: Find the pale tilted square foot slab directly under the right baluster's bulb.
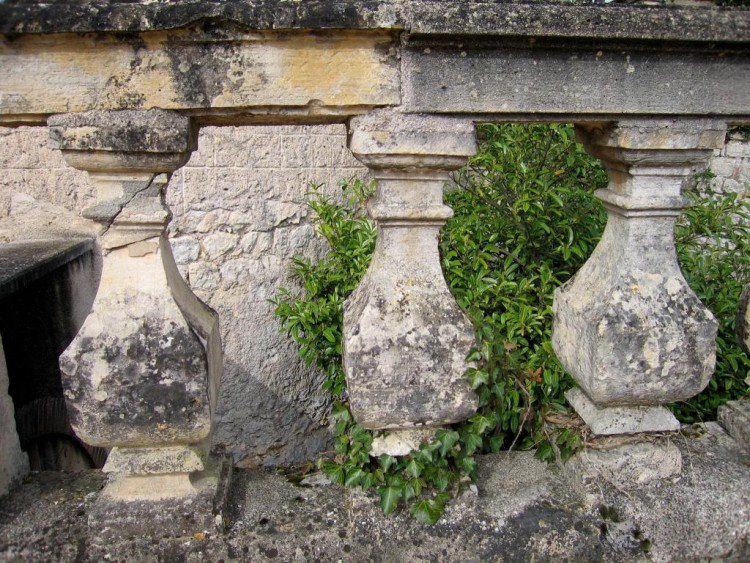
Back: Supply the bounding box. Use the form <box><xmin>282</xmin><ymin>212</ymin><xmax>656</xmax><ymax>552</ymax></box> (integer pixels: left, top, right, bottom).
<box><xmin>565</xmin><ymin>388</ymin><xmax>680</xmax><ymax>436</ymax></box>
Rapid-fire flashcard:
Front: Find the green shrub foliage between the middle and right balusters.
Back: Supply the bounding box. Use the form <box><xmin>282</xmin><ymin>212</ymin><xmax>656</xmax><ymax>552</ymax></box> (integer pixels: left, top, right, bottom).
<box><xmin>440</xmin><ymin>125</ymin><xmax>607</xmax><ymax>459</ymax></box>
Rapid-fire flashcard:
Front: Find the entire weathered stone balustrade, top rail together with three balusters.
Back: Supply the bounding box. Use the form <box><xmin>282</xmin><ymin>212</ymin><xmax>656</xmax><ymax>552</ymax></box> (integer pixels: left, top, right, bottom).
<box><xmin>0</xmin><ymin>0</ymin><xmax>750</xmax><ymax>534</ymax></box>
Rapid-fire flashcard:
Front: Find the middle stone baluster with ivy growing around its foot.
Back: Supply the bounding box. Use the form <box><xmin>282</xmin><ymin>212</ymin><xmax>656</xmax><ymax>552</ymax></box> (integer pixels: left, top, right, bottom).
<box><xmin>343</xmin><ymin>110</ymin><xmax>477</xmax><ymax>454</ymax></box>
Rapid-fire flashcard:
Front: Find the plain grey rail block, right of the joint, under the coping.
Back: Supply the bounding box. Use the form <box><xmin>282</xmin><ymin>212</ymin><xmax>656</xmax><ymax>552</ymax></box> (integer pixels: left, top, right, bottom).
<box><xmin>401</xmin><ymin>41</ymin><xmax>750</xmax><ymax>121</ymax></box>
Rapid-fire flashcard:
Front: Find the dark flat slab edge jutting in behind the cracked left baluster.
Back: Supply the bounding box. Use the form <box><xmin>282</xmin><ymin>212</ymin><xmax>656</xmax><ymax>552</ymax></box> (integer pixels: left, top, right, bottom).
<box><xmin>0</xmin><ymin>238</ymin><xmax>94</xmax><ymax>299</ymax></box>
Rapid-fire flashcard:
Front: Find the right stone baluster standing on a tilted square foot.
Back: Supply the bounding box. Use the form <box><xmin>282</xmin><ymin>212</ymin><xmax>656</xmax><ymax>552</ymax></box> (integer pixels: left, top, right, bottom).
<box><xmin>552</xmin><ymin>120</ymin><xmax>725</xmax><ymax>480</ymax></box>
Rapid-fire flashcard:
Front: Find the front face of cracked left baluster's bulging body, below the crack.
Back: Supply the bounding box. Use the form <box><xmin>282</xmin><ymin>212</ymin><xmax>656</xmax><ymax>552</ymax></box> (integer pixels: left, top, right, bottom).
<box><xmin>60</xmin><ymin>239</ymin><xmax>211</xmax><ymax>447</ymax></box>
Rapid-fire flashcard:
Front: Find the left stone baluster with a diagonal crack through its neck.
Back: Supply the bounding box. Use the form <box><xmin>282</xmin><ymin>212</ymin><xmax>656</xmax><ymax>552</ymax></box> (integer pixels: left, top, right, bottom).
<box><xmin>48</xmin><ymin>110</ymin><xmax>226</xmax><ymax>535</ymax></box>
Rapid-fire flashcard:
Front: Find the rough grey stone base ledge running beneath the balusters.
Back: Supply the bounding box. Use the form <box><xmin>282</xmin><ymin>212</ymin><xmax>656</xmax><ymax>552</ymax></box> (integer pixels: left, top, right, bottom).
<box><xmin>0</xmin><ymin>423</ymin><xmax>750</xmax><ymax>562</ymax></box>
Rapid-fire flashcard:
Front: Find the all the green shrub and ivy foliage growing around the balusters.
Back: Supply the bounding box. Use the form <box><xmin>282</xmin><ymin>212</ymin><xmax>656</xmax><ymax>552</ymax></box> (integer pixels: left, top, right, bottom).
<box><xmin>274</xmin><ymin>121</ymin><xmax>750</xmax><ymax>523</ymax></box>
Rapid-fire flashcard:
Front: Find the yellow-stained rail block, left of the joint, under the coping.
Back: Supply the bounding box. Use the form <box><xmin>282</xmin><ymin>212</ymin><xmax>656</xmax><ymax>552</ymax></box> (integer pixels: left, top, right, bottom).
<box><xmin>0</xmin><ymin>28</ymin><xmax>401</xmax><ymax>118</ymax></box>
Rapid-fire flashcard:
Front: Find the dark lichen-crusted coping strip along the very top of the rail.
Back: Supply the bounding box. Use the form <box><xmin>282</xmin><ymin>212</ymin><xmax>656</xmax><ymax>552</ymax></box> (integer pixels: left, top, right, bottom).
<box><xmin>0</xmin><ymin>0</ymin><xmax>750</xmax><ymax>43</ymax></box>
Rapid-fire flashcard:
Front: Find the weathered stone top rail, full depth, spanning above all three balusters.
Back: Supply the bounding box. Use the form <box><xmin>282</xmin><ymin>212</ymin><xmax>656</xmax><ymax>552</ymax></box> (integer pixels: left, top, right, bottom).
<box><xmin>0</xmin><ymin>0</ymin><xmax>750</xmax><ymax>125</ymax></box>
